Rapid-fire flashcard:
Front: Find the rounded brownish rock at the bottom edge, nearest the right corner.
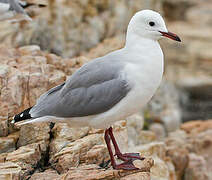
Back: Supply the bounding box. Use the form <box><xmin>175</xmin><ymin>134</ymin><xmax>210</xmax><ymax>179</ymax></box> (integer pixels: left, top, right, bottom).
<box><xmin>184</xmin><ymin>153</ymin><xmax>210</xmax><ymax>180</ymax></box>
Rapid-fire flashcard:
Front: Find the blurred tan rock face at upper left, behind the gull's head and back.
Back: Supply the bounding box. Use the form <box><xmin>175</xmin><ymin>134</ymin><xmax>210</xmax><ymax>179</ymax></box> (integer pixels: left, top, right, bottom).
<box><xmin>0</xmin><ymin>0</ymin><xmax>161</xmax><ymax>57</ymax></box>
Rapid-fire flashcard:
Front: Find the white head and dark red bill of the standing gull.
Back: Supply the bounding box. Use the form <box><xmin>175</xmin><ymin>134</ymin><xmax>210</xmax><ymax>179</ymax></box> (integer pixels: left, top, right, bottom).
<box><xmin>128</xmin><ymin>10</ymin><xmax>181</xmax><ymax>42</ymax></box>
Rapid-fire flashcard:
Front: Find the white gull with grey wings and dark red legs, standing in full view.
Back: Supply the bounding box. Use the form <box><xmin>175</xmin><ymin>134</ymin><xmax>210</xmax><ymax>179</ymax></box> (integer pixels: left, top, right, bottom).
<box><xmin>12</xmin><ymin>10</ymin><xmax>181</xmax><ymax>170</ymax></box>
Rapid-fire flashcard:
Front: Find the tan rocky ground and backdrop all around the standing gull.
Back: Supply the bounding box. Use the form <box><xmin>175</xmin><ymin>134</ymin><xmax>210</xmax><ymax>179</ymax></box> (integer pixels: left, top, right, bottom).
<box><xmin>0</xmin><ymin>0</ymin><xmax>212</xmax><ymax>180</ymax></box>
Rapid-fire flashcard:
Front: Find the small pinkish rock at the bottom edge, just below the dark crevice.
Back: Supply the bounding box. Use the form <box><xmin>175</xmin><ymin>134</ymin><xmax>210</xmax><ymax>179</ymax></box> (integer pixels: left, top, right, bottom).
<box><xmin>30</xmin><ymin>169</ymin><xmax>61</xmax><ymax>180</ymax></box>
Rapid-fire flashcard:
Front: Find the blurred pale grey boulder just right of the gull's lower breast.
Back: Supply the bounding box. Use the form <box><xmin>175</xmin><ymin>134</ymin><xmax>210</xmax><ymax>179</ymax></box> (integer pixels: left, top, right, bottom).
<box><xmin>146</xmin><ymin>81</ymin><xmax>181</xmax><ymax>133</ymax></box>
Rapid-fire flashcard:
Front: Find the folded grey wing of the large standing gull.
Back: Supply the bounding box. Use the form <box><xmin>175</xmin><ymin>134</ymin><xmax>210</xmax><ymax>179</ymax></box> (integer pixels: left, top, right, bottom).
<box><xmin>30</xmin><ymin>58</ymin><xmax>130</xmax><ymax>117</ymax></box>
